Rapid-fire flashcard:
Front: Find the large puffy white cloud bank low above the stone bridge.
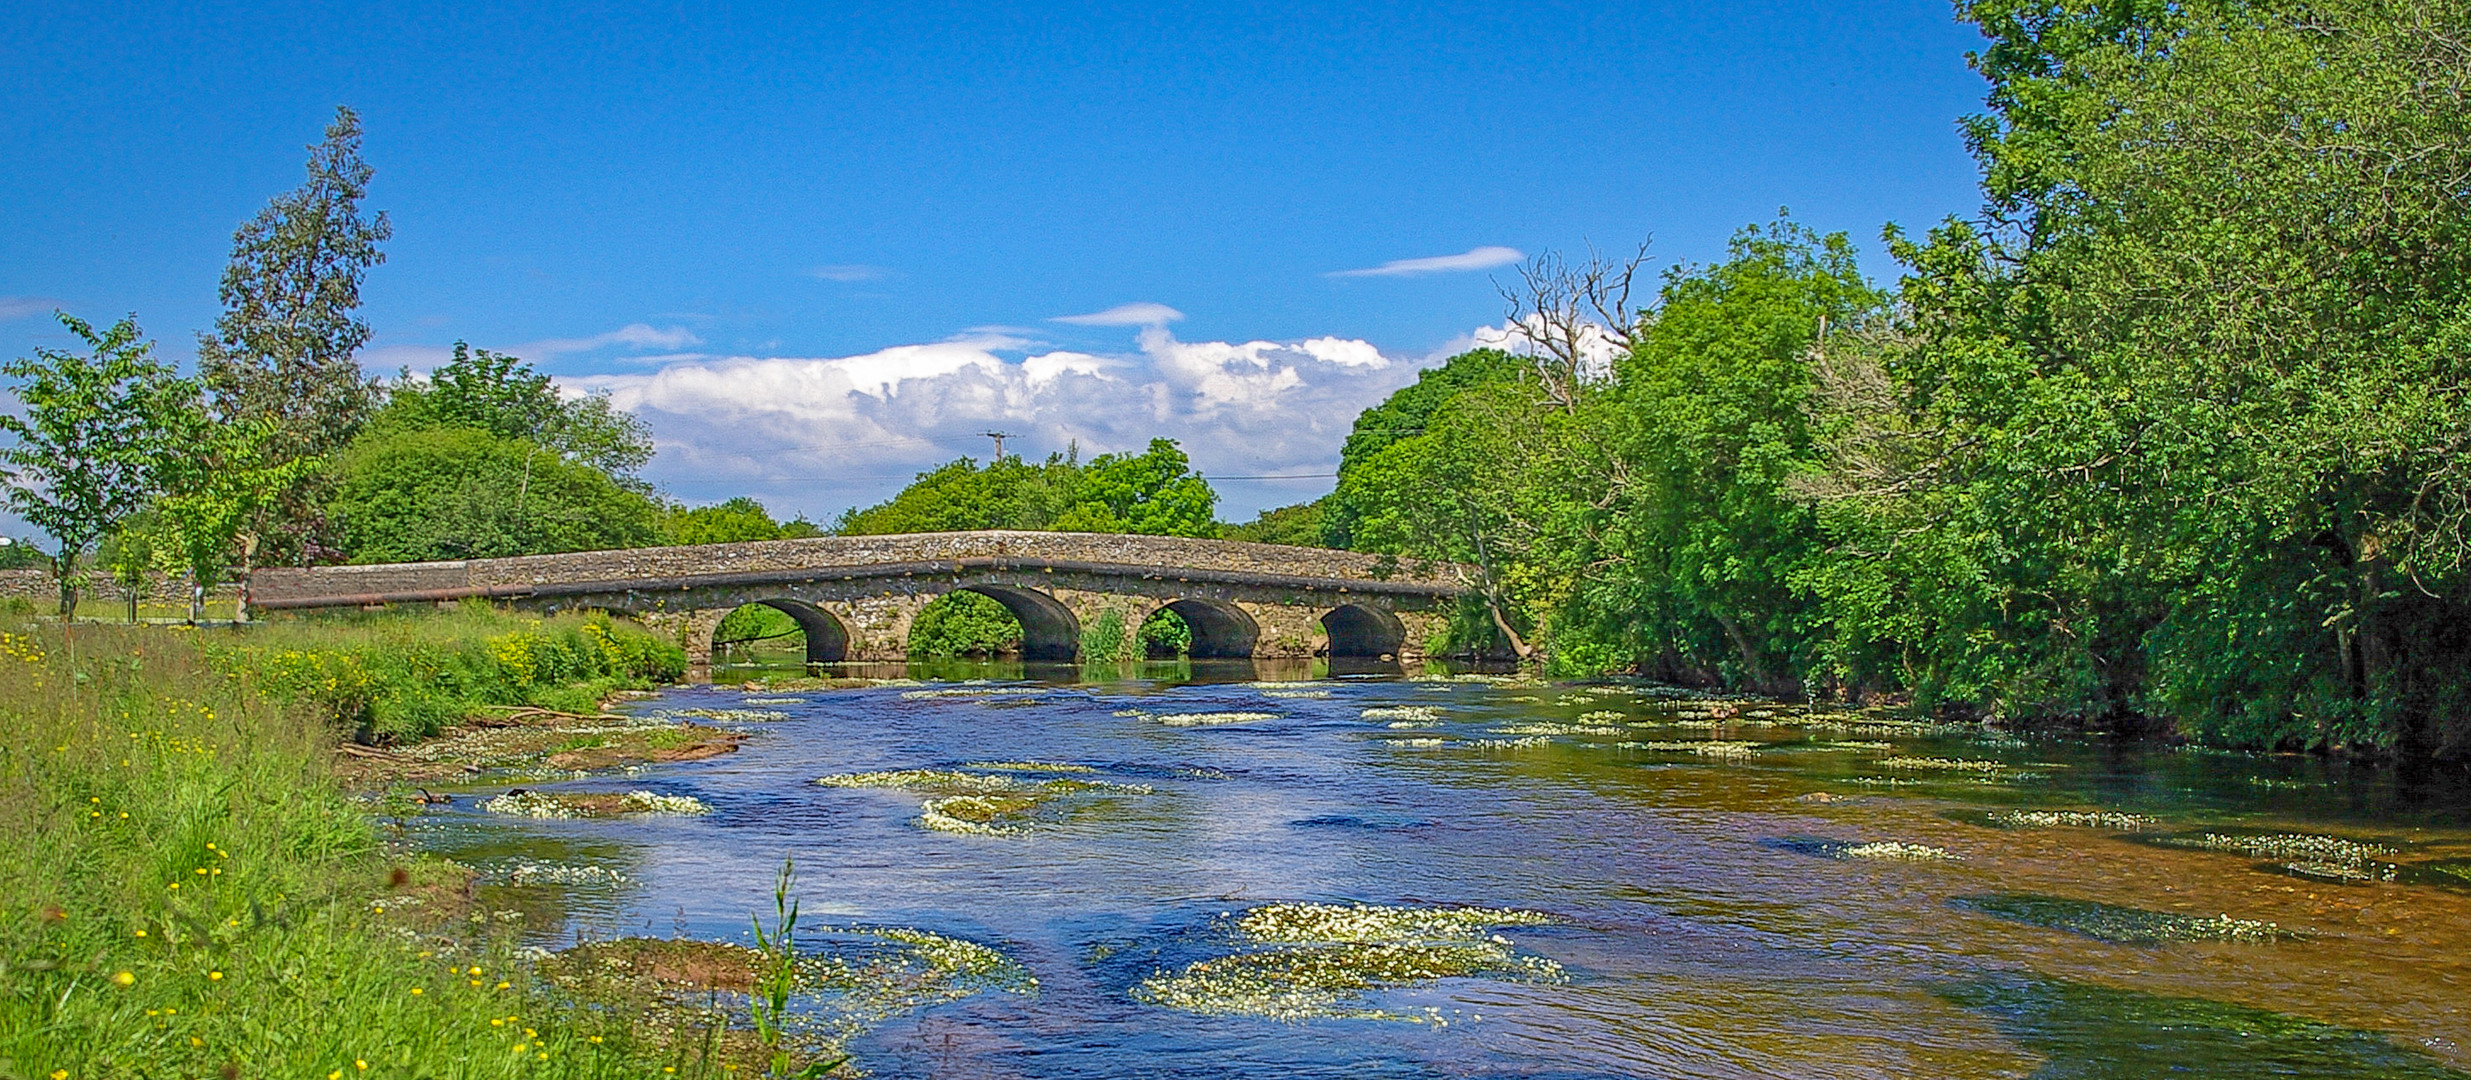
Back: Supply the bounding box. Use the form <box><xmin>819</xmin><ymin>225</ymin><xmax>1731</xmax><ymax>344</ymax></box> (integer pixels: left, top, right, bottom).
<box><xmin>563</xmin><ymin>321</ymin><xmax>1438</xmax><ymax>517</ymax></box>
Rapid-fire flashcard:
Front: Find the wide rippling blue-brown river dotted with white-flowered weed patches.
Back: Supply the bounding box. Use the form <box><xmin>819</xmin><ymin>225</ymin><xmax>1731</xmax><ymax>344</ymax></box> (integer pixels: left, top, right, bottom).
<box><xmin>415</xmin><ymin>667</ymin><xmax>2471</xmax><ymax>1080</ymax></box>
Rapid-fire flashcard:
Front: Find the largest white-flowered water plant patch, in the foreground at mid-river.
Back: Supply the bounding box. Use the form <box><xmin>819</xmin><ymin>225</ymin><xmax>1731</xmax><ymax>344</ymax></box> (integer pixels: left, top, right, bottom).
<box><xmin>1129</xmin><ymin>905</ymin><xmax>1564</xmax><ymax>1021</ymax></box>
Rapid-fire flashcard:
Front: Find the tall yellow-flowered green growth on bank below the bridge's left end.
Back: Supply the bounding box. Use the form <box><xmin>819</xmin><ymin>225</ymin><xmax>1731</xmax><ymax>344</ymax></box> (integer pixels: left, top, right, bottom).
<box><xmin>198</xmin><ymin>603</ymin><xmax>687</xmax><ymax>744</ymax></box>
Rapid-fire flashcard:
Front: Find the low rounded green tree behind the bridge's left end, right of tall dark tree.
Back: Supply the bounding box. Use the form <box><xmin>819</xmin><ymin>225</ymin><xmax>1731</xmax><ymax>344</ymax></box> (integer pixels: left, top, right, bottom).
<box><xmin>329</xmin><ymin>428</ymin><xmax>660</xmax><ymax>563</ymax></box>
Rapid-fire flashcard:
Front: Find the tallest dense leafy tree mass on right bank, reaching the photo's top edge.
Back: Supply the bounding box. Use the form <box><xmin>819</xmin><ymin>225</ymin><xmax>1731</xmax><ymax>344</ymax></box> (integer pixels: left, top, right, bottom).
<box><xmin>1811</xmin><ymin>0</ymin><xmax>2471</xmax><ymax>754</ymax></box>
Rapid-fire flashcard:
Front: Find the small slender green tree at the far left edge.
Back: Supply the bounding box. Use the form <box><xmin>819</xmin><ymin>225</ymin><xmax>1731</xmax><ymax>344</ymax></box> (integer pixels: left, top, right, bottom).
<box><xmin>0</xmin><ymin>314</ymin><xmax>183</xmax><ymax>620</ymax></box>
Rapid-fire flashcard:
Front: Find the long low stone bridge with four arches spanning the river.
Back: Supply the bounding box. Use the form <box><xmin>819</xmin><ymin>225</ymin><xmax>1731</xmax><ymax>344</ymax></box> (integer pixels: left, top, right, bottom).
<box><xmin>250</xmin><ymin>531</ymin><xmax>1463</xmax><ymax>662</ymax></box>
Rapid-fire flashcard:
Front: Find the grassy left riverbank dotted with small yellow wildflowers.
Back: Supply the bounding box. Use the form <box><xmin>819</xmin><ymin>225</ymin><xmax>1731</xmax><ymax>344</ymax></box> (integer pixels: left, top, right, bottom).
<box><xmin>0</xmin><ymin>610</ymin><xmax>721</xmax><ymax>1080</ymax></box>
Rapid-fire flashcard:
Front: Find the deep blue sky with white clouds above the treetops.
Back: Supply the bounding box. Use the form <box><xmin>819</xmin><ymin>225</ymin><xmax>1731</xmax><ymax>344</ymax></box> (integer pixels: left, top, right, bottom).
<box><xmin>0</xmin><ymin>0</ymin><xmax>1982</xmax><ymax>531</ymax></box>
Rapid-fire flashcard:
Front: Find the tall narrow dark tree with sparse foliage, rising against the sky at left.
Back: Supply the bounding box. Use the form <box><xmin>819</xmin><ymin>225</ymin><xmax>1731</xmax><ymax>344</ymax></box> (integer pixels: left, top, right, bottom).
<box><xmin>198</xmin><ymin>106</ymin><xmax>393</xmax><ymax>554</ymax></box>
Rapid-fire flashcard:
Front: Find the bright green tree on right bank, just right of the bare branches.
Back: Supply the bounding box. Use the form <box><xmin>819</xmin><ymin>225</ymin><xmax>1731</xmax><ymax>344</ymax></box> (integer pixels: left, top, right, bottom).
<box><xmin>1557</xmin><ymin>220</ymin><xmax>1885</xmax><ymax>694</ymax></box>
